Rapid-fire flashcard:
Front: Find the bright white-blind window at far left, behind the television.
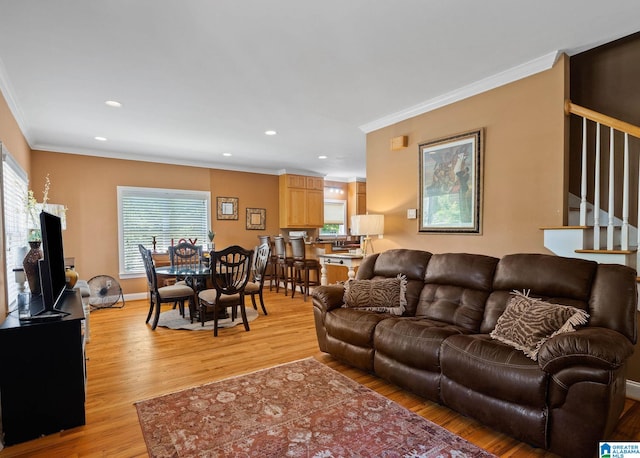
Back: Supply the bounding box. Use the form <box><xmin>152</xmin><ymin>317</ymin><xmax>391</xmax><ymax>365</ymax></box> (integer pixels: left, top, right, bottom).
<box><xmin>0</xmin><ymin>145</ymin><xmax>28</xmax><ymax>310</ymax></box>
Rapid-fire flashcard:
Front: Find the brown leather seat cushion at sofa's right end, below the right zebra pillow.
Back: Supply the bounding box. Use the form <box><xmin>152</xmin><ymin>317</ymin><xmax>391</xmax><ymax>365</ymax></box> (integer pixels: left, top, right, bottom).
<box><xmin>440</xmin><ymin>334</ymin><xmax>548</xmax><ymax>409</ymax></box>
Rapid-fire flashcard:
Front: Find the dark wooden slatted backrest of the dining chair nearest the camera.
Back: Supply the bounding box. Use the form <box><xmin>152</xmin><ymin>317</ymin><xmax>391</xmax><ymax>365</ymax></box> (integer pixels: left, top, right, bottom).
<box><xmin>211</xmin><ymin>245</ymin><xmax>253</xmax><ymax>296</ymax></box>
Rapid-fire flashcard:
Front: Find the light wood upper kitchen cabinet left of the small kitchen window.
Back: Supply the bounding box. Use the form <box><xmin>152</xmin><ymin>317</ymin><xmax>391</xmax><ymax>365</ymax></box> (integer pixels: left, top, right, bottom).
<box><xmin>279</xmin><ymin>174</ymin><xmax>324</xmax><ymax>228</ymax></box>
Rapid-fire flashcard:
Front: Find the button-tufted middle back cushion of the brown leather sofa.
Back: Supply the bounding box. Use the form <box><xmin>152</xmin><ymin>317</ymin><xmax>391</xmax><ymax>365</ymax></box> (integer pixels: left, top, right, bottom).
<box><xmin>416</xmin><ymin>253</ymin><xmax>499</xmax><ymax>332</ymax></box>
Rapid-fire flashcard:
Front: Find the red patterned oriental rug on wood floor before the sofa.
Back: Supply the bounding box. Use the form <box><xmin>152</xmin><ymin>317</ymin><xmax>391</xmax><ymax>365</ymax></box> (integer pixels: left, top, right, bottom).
<box><xmin>135</xmin><ymin>358</ymin><xmax>494</xmax><ymax>458</ymax></box>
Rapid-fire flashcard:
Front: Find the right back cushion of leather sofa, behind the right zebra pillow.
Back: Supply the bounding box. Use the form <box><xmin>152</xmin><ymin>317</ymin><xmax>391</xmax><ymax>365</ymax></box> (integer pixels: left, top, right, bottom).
<box><xmin>480</xmin><ymin>253</ymin><xmax>598</xmax><ymax>333</ymax></box>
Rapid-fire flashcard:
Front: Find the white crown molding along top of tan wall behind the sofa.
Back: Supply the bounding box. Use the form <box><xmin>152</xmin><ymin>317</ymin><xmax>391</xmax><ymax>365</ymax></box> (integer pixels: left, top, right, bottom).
<box><xmin>360</xmin><ymin>51</ymin><xmax>562</xmax><ymax>134</ymax></box>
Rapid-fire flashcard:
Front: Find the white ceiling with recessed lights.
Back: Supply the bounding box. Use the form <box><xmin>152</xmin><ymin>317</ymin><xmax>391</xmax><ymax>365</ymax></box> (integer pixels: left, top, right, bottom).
<box><xmin>0</xmin><ymin>0</ymin><xmax>640</xmax><ymax>180</ymax></box>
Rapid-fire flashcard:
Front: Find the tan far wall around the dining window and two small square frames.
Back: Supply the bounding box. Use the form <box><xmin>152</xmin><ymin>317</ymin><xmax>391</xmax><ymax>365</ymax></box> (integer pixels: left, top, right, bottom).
<box><xmin>31</xmin><ymin>151</ymin><xmax>278</xmax><ymax>294</ymax></box>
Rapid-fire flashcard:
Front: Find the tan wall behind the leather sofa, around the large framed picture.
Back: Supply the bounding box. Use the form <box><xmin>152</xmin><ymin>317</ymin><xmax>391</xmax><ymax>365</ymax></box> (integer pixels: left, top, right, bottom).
<box><xmin>367</xmin><ymin>54</ymin><xmax>567</xmax><ymax>256</ymax></box>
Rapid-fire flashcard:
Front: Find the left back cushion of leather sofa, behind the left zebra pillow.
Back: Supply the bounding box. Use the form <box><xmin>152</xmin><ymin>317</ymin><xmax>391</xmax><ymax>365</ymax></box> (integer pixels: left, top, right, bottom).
<box><xmin>356</xmin><ymin>249</ymin><xmax>431</xmax><ymax>316</ymax></box>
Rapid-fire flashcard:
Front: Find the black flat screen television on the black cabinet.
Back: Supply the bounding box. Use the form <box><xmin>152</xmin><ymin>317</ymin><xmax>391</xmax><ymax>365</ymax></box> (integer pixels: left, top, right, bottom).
<box><xmin>36</xmin><ymin>212</ymin><xmax>67</xmax><ymax>315</ymax></box>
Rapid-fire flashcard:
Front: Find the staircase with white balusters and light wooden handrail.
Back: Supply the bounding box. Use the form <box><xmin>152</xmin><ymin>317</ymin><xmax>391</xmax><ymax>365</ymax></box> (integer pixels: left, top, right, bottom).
<box><xmin>543</xmin><ymin>101</ymin><xmax>640</xmax><ymax>269</ymax></box>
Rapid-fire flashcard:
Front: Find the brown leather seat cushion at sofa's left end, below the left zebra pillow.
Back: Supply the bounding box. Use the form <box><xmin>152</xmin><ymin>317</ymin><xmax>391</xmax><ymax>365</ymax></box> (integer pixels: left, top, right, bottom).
<box><xmin>324</xmin><ymin>307</ymin><xmax>390</xmax><ymax>348</ymax></box>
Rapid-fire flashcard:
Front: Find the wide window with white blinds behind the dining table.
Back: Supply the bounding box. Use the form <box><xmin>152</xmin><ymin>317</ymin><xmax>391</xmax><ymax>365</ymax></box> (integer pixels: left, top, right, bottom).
<box><xmin>118</xmin><ymin>186</ymin><xmax>211</xmax><ymax>278</ymax></box>
